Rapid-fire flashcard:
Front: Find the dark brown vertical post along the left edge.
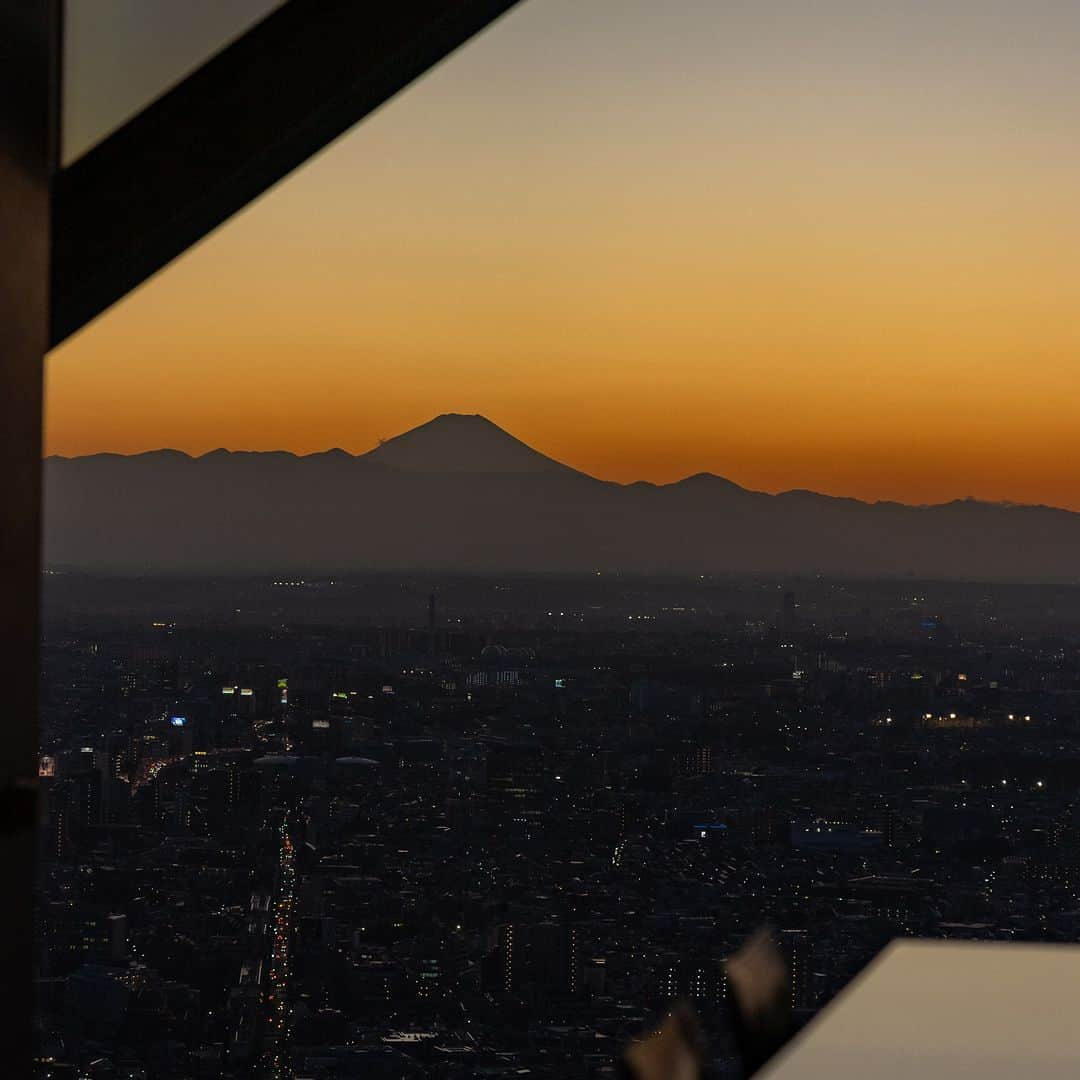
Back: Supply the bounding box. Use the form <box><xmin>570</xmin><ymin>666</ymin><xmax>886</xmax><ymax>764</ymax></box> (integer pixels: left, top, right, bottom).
<box><xmin>0</xmin><ymin>0</ymin><xmax>58</xmax><ymax>1077</ymax></box>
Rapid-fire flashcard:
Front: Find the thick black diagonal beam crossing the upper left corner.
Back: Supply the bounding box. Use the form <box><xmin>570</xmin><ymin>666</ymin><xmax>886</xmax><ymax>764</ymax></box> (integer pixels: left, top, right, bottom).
<box><xmin>52</xmin><ymin>0</ymin><xmax>516</xmax><ymax>345</ymax></box>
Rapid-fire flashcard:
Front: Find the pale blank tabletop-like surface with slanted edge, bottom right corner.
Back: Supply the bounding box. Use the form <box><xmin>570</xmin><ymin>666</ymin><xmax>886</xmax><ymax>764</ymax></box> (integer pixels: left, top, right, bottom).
<box><xmin>758</xmin><ymin>941</ymin><xmax>1080</xmax><ymax>1080</ymax></box>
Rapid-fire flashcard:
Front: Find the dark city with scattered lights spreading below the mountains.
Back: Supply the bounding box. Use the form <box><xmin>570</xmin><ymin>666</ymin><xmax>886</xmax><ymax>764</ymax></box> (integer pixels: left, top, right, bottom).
<box><xmin>36</xmin><ymin>571</ymin><xmax>1080</xmax><ymax>1080</ymax></box>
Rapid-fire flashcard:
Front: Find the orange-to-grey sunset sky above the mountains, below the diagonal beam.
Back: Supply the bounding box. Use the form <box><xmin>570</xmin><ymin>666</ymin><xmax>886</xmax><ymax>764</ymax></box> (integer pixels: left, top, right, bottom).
<box><xmin>46</xmin><ymin>0</ymin><xmax>1080</xmax><ymax>509</ymax></box>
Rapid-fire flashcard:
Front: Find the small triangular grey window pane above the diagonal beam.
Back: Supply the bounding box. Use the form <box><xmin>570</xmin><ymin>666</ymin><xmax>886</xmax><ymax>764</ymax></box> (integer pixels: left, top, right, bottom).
<box><xmin>63</xmin><ymin>0</ymin><xmax>282</xmax><ymax>164</ymax></box>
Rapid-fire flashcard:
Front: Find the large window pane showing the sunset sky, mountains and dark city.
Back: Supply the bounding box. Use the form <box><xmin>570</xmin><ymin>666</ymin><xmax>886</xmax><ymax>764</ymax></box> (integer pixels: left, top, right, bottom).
<box><xmin>38</xmin><ymin>0</ymin><xmax>1080</xmax><ymax>1080</ymax></box>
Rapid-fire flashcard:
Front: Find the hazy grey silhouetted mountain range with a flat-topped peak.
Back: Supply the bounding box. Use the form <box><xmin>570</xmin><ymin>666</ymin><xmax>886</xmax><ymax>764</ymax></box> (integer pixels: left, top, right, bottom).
<box><xmin>44</xmin><ymin>414</ymin><xmax>1080</xmax><ymax>581</ymax></box>
